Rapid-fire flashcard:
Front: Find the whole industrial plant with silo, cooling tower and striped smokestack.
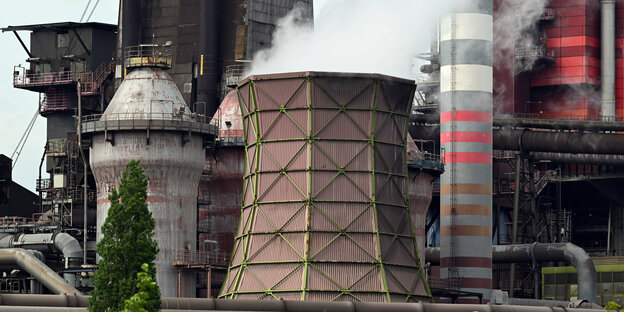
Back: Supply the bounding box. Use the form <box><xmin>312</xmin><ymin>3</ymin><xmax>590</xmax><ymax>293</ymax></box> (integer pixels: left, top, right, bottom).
<box><xmin>0</xmin><ymin>0</ymin><xmax>624</xmax><ymax>311</ymax></box>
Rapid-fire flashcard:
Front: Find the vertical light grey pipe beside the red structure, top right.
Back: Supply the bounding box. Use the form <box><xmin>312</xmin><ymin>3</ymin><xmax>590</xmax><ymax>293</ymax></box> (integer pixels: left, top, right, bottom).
<box><xmin>600</xmin><ymin>0</ymin><xmax>615</xmax><ymax>120</ymax></box>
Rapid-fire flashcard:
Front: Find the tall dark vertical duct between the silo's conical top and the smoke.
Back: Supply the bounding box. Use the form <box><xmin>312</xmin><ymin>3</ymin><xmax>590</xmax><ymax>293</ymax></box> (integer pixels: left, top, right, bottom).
<box><xmin>196</xmin><ymin>0</ymin><xmax>219</xmax><ymax>117</ymax></box>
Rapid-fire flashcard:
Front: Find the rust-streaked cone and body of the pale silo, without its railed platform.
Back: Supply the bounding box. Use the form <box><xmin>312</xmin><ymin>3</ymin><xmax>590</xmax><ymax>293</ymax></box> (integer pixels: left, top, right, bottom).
<box><xmin>90</xmin><ymin>68</ymin><xmax>205</xmax><ymax>296</ymax></box>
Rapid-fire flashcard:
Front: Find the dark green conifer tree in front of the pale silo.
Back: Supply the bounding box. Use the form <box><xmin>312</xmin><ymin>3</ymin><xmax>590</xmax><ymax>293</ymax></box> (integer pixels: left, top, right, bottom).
<box><xmin>89</xmin><ymin>160</ymin><xmax>161</xmax><ymax>312</ymax></box>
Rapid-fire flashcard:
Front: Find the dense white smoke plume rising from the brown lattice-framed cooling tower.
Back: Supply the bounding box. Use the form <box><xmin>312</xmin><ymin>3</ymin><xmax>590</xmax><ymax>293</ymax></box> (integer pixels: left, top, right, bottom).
<box><xmin>247</xmin><ymin>0</ymin><xmax>461</xmax><ymax>79</ymax></box>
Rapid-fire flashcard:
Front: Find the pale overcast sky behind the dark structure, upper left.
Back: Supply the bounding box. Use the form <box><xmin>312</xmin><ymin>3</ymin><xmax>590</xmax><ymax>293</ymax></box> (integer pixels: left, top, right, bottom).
<box><xmin>0</xmin><ymin>0</ymin><xmax>330</xmax><ymax>191</ymax></box>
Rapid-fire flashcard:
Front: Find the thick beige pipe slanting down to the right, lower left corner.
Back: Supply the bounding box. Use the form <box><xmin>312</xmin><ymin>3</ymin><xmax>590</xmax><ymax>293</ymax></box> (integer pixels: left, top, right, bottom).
<box><xmin>0</xmin><ymin>248</ymin><xmax>80</xmax><ymax>295</ymax></box>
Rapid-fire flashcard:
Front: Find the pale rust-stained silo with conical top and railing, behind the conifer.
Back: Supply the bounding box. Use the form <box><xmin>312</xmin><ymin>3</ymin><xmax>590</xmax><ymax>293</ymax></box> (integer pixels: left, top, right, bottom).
<box><xmin>83</xmin><ymin>49</ymin><xmax>216</xmax><ymax>297</ymax></box>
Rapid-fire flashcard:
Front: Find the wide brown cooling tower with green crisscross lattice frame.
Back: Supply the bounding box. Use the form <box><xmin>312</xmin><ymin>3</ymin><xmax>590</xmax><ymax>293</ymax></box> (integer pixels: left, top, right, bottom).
<box><xmin>221</xmin><ymin>72</ymin><xmax>430</xmax><ymax>302</ymax></box>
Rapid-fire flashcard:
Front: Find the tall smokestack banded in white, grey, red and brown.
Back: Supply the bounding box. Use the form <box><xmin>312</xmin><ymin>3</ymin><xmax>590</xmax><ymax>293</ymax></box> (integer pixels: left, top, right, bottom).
<box><xmin>440</xmin><ymin>0</ymin><xmax>493</xmax><ymax>303</ymax></box>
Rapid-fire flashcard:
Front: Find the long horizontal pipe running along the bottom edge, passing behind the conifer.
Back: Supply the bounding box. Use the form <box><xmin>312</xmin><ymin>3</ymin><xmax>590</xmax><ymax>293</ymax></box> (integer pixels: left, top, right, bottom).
<box><xmin>0</xmin><ymin>294</ymin><xmax>604</xmax><ymax>312</ymax></box>
